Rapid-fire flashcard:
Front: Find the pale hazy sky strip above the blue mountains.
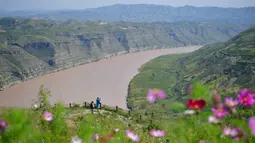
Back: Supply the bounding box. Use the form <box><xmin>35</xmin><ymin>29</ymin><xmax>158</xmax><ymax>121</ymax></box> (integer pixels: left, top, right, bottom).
<box><xmin>0</xmin><ymin>0</ymin><xmax>255</xmax><ymax>10</ymax></box>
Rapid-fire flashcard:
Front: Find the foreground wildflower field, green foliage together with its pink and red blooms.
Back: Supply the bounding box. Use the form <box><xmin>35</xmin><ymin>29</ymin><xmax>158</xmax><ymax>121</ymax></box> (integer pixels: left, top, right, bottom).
<box><xmin>0</xmin><ymin>81</ymin><xmax>255</xmax><ymax>143</ymax></box>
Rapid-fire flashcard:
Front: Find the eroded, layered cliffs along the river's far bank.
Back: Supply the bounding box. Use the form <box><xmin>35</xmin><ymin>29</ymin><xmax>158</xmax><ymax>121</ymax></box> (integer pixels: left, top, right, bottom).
<box><xmin>0</xmin><ymin>19</ymin><xmax>248</xmax><ymax>89</ymax></box>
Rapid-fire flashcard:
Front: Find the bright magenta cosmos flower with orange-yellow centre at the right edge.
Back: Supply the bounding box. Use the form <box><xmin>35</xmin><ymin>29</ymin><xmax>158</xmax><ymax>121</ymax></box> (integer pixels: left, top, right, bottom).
<box><xmin>237</xmin><ymin>89</ymin><xmax>255</xmax><ymax>106</ymax></box>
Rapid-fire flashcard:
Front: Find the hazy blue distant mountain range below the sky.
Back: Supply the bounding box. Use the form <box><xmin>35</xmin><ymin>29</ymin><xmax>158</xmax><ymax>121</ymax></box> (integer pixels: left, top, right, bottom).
<box><xmin>0</xmin><ymin>4</ymin><xmax>255</xmax><ymax>25</ymax></box>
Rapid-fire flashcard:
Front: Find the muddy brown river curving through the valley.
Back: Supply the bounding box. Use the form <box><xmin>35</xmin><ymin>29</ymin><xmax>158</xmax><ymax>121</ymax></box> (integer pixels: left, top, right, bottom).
<box><xmin>0</xmin><ymin>46</ymin><xmax>200</xmax><ymax>109</ymax></box>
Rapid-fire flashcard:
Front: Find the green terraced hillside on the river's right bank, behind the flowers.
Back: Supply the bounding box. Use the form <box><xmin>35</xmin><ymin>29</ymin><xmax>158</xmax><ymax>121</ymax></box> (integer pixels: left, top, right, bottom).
<box><xmin>127</xmin><ymin>27</ymin><xmax>255</xmax><ymax>112</ymax></box>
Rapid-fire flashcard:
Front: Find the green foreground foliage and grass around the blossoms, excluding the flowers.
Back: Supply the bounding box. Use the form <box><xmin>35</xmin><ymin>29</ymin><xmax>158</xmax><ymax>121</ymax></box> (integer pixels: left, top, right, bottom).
<box><xmin>0</xmin><ymin>83</ymin><xmax>255</xmax><ymax>143</ymax></box>
